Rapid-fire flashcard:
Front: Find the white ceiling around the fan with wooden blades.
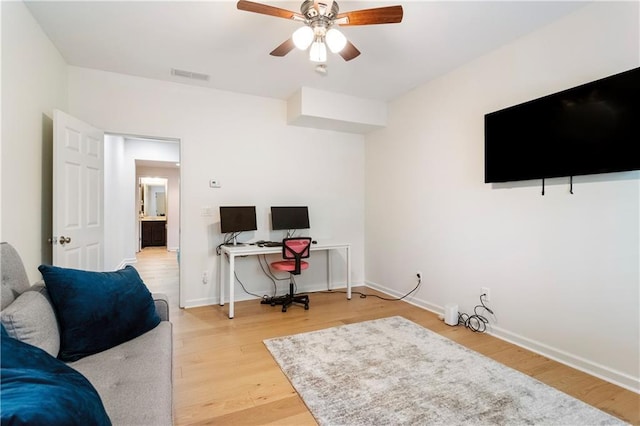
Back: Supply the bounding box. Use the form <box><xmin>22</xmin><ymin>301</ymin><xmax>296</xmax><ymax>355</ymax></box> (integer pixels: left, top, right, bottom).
<box><xmin>26</xmin><ymin>0</ymin><xmax>586</xmax><ymax>101</ymax></box>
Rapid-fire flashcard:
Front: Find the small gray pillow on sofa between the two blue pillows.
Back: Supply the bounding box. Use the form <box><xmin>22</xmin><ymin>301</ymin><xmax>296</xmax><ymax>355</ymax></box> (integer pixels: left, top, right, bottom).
<box><xmin>0</xmin><ymin>287</ymin><xmax>60</xmax><ymax>357</ymax></box>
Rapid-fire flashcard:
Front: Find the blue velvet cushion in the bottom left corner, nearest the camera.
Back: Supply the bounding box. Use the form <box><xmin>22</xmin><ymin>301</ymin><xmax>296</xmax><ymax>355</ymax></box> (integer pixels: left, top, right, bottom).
<box><xmin>0</xmin><ymin>333</ymin><xmax>111</xmax><ymax>425</ymax></box>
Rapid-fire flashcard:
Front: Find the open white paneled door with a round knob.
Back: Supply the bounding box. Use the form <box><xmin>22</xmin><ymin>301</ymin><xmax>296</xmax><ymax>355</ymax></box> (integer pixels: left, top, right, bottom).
<box><xmin>52</xmin><ymin>110</ymin><xmax>104</xmax><ymax>271</ymax></box>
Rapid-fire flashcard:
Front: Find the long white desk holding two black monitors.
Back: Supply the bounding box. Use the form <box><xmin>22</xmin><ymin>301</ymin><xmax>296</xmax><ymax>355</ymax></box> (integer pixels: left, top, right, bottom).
<box><xmin>218</xmin><ymin>243</ymin><xmax>351</xmax><ymax>318</ymax></box>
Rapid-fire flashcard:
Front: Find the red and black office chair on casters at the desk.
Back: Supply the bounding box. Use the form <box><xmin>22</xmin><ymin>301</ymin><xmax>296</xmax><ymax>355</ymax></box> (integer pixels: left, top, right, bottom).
<box><xmin>271</xmin><ymin>237</ymin><xmax>311</xmax><ymax>312</ymax></box>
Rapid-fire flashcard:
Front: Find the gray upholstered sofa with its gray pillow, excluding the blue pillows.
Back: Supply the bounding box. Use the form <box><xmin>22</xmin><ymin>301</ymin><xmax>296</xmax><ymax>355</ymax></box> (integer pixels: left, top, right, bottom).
<box><xmin>0</xmin><ymin>243</ymin><xmax>173</xmax><ymax>426</ymax></box>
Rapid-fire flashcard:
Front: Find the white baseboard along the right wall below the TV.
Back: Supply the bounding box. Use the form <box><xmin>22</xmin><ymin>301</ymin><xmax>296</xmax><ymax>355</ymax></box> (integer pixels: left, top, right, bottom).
<box><xmin>365</xmin><ymin>281</ymin><xmax>640</xmax><ymax>393</ymax></box>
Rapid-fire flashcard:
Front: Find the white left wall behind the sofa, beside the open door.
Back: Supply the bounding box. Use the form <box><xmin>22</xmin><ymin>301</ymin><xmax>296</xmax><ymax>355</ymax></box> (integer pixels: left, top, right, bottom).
<box><xmin>0</xmin><ymin>1</ymin><xmax>67</xmax><ymax>281</ymax></box>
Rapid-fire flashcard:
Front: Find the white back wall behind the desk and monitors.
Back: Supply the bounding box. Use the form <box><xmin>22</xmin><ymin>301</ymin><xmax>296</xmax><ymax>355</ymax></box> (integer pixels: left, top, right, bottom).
<box><xmin>69</xmin><ymin>67</ymin><xmax>364</xmax><ymax>309</ymax></box>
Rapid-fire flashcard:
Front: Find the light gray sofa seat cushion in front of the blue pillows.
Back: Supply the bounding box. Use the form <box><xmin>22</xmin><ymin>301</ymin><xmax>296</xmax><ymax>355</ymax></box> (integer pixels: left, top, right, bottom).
<box><xmin>69</xmin><ymin>321</ymin><xmax>173</xmax><ymax>426</ymax></box>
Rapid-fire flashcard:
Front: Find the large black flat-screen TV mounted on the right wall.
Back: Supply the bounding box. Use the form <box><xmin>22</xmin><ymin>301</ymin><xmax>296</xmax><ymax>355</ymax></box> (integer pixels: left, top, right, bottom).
<box><xmin>484</xmin><ymin>68</ymin><xmax>640</xmax><ymax>183</ymax></box>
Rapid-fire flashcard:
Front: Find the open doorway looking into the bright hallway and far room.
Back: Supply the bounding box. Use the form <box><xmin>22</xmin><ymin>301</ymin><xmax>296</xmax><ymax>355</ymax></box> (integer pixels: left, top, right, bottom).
<box><xmin>105</xmin><ymin>134</ymin><xmax>183</xmax><ymax>306</ymax></box>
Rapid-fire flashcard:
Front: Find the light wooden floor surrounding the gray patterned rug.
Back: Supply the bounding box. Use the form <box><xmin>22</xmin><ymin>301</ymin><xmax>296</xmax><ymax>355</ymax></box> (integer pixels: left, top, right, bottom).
<box><xmin>132</xmin><ymin>251</ymin><xmax>640</xmax><ymax>425</ymax></box>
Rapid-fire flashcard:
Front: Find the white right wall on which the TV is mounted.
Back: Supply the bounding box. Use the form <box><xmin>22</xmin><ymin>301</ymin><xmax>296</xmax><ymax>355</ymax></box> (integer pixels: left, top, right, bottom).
<box><xmin>365</xmin><ymin>2</ymin><xmax>640</xmax><ymax>391</ymax></box>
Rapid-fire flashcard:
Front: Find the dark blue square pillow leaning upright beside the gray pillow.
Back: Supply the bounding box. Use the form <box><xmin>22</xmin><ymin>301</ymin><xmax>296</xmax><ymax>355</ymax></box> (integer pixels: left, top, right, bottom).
<box><xmin>38</xmin><ymin>265</ymin><xmax>160</xmax><ymax>361</ymax></box>
